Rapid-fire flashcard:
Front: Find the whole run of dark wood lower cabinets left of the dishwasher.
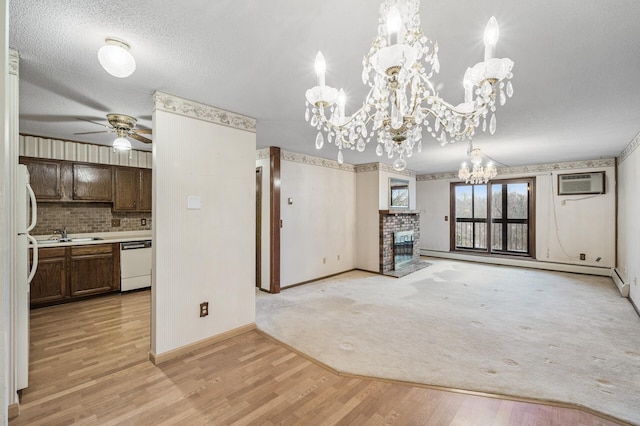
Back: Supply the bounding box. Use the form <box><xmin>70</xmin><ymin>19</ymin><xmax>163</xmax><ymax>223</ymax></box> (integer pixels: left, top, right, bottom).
<box><xmin>31</xmin><ymin>243</ymin><xmax>120</xmax><ymax>307</ymax></box>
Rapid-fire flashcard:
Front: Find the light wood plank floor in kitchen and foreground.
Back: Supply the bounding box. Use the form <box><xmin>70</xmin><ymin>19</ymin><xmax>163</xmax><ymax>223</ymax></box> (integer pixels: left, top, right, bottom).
<box><xmin>9</xmin><ymin>291</ymin><xmax>618</xmax><ymax>426</ymax></box>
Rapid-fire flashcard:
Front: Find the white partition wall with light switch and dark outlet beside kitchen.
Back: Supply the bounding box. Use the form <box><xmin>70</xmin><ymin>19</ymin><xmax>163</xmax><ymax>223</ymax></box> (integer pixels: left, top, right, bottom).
<box><xmin>151</xmin><ymin>93</ymin><xmax>256</xmax><ymax>355</ymax></box>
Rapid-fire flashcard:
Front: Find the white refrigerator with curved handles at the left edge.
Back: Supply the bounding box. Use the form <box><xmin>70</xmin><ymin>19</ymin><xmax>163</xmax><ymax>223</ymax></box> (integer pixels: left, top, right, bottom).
<box><xmin>15</xmin><ymin>164</ymin><xmax>38</xmax><ymax>390</ymax></box>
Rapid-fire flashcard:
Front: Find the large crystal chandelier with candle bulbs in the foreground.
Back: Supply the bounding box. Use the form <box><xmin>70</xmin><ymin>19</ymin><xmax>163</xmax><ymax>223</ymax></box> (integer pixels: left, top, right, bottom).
<box><xmin>305</xmin><ymin>0</ymin><xmax>513</xmax><ymax>171</ymax></box>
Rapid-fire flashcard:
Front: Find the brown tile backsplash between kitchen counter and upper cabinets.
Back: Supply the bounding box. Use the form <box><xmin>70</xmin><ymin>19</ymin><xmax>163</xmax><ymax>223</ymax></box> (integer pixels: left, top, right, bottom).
<box><xmin>31</xmin><ymin>203</ymin><xmax>151</xmax><ymax>235</ymax></box>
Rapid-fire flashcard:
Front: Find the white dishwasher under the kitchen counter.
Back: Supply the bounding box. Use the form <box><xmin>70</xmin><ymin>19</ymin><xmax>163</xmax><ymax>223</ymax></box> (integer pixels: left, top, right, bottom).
<box><xmin>120</xmin><ymin>240</ymin><xmax>151</xmax><ymax>291</ymax></box>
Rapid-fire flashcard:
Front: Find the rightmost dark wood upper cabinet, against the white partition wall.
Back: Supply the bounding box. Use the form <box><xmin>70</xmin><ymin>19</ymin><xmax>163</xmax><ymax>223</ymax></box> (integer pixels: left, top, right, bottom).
<box><xmin>113</xmin><ymin>167</ymin><xmax>151</xmax><ymax>212</ymax></box>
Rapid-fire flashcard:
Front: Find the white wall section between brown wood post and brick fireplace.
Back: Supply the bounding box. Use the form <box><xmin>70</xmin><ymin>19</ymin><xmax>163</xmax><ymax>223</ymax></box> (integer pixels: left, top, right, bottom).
<box><xmin>280</xmin><ymin>153</ymin><xmax>356</xmax><ymax>288</ymax></box>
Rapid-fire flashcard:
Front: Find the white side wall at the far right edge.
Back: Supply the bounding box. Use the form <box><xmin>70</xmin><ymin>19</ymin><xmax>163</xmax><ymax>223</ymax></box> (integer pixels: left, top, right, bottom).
<box><xmin>616</xmin><ymin>134</ymin><xmax>640</xmax><ymax>306</ymax></box>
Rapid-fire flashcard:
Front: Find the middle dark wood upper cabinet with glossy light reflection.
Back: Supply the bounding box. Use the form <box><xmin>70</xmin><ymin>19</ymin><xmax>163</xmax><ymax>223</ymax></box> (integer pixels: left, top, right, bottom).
<box><xmin>73</xmin><ymin>163</ymin><xmax>113</xmax><ymax>202</ymax></box>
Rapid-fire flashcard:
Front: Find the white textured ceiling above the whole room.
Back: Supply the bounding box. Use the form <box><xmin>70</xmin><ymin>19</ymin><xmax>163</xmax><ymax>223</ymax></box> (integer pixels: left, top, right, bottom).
<box><xmin>9</xmin><ymin>0</ymin><xmax>640</xmax><ymax>173</ymax></box>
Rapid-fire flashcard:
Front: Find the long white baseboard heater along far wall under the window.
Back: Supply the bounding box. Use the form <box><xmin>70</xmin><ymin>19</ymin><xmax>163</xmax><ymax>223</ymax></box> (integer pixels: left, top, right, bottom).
<box><xmin>420</xmin><ymin>249</ymin><xmax>612</xmax><ymax>278</ymax></box>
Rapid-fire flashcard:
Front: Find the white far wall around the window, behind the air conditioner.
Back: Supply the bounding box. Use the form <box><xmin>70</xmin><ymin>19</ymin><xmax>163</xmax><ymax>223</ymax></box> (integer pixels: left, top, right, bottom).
<box><xmin>417</xmin><ymin>159</ymin><xmax>616</xmax><ymax>268</ymax></box>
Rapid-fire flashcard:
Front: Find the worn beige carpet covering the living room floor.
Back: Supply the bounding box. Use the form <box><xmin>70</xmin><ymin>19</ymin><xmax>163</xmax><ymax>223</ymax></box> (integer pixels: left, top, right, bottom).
<box><xmin>256</xmin><ymin>259</ymin><xmax>640</xmax><ymax>424</ymax></box>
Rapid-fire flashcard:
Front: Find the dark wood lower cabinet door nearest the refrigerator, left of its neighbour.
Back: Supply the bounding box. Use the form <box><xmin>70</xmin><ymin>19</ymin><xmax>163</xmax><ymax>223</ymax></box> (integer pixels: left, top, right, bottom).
<box><xmin>30</xmin><ymin>247</ymin><xmax>69</xmax><ymax>306</ymax></box>
